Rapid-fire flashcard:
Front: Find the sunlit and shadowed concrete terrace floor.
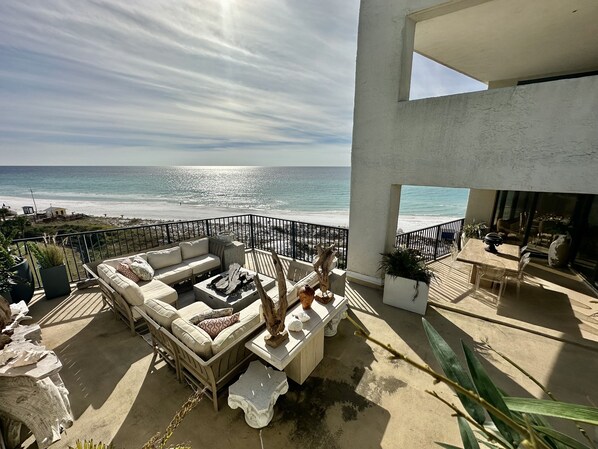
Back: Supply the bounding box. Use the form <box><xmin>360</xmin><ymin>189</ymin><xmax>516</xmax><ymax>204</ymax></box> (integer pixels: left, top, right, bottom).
<box><xmin>18</xmin><ymin>253</ymin><xmax>598</xmax><ymax>449</ymax></box>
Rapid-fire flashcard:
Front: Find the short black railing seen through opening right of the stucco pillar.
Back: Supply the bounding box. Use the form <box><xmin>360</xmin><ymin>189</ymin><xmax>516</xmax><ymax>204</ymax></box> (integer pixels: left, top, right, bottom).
<box><xmin>395</xmin><ymin>218</ymin><xmax>465</xmax><ymax>262</ymax></box>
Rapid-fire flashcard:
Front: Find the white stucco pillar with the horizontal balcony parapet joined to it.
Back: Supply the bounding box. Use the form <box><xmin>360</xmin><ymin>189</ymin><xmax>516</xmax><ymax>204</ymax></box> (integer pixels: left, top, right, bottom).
<box><xmin>348</xmin><ymin>0</ymin><xmax>598</xmax><ymax>283</ymax></box>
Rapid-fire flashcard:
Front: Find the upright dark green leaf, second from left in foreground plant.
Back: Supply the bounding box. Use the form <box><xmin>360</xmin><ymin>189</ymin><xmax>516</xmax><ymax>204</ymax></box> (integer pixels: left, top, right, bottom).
<box><xmin>461</xmin><ymin>342</ymin><xmax>521</xmax><ymax>447</ymax></box>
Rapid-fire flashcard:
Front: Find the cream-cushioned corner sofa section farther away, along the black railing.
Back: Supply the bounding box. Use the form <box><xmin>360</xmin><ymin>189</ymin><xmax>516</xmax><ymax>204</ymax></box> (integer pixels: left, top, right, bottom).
<box><xmin>85</xmin><ymin>237</ymin><xmax>229</xmax><ymax>334</ymax></box>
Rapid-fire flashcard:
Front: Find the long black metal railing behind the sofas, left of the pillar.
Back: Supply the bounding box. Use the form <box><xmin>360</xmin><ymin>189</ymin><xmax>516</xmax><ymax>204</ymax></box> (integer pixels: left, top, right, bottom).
<box><xmin>14</xmin><ymin>214</ymin><xmax>349</xmax><ymax>287</ymax></box>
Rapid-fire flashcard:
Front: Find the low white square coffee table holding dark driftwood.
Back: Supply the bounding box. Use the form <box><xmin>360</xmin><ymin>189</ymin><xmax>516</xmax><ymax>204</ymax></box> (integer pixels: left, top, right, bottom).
<box><xmin>193</xmin><ymin>269</ymin><xmax>274</xmax><ymax>313</ymax></box>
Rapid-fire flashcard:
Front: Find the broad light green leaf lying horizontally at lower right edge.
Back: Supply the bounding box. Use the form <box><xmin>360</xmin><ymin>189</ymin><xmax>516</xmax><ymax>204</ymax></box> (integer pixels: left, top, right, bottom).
<box><xmin>504</xmin><ymin>397</ymin><xmax>598</xmax><ymax>426</ymax></box>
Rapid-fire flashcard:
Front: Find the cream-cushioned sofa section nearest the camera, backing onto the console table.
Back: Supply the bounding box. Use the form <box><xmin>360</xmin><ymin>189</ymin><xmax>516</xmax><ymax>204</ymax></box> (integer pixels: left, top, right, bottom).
<box><xmin>138</xmin><ymin>261</ymin><xmax>345</xmax><ymax>411</ymax></box>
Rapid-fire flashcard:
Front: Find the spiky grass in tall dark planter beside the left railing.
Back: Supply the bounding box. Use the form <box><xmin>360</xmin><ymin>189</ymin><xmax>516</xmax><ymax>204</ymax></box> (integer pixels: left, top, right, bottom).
<box><xmin>29</xmin><ymin>236</ymin><xmax>71</xmax><ymax>299</ymax></box>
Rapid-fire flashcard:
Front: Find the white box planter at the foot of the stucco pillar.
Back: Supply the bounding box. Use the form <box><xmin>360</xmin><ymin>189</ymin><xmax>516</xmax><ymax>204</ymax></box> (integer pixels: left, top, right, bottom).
<box><xmin>382</xmin><ymin>275</ymin><xmax>429</xmax><ymax>315</ymax></box>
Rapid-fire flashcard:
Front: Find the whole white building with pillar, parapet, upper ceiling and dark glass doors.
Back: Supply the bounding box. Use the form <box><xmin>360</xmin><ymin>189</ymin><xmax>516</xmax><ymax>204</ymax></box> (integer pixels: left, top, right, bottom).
<box><xmin>348</xmin><ymin>0</ymin><xmax>598</xmax><ymax>285</ymax></box>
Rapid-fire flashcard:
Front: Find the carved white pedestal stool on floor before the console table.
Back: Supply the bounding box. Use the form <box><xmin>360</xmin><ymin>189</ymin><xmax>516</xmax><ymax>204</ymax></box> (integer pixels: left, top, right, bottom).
<box><xmin>228</xmin><ymin>360</ymin><xmax>289</xmax><ymax>429</ymax></box>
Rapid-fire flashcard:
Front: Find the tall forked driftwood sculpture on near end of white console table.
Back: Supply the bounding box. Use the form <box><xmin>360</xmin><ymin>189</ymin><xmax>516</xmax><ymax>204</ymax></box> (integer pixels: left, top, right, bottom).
<box><xmin>253</xmin><ymin>251</ymin><xmax>289</xmax><ymax>348</ymax></box>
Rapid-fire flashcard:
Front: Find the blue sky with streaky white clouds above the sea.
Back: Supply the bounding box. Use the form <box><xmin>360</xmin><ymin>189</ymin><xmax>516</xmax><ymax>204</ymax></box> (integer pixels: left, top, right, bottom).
<box><xmin>0</xmin><ymin>0</ymin><xmax>485</xmax><ymax>166</ymax></box>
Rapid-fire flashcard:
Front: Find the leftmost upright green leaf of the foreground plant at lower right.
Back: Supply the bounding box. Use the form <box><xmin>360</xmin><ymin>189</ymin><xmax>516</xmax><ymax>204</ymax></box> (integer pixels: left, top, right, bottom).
<box><xmin>422</xmin><ymin>318</ymin><xmax>486</xmax><ymax>424</ymax></box>
